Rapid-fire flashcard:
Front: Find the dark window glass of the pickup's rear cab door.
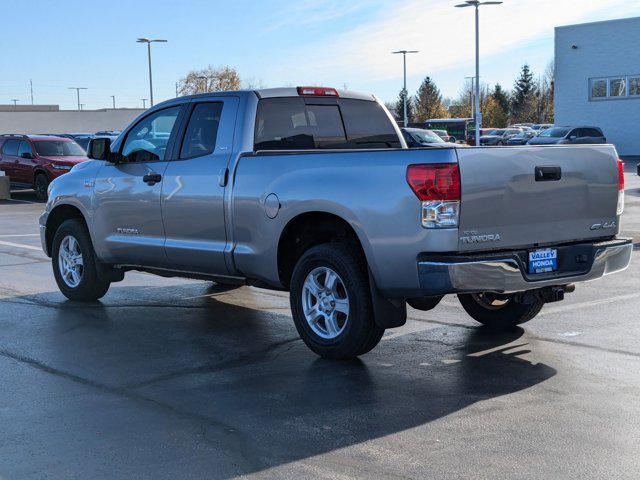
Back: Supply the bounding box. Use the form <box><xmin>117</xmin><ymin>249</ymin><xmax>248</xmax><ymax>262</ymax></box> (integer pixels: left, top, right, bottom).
<box><xmin>180</xmin><ymin>102</ymin><xmax>223</xmax><ymax>158</ymax></box>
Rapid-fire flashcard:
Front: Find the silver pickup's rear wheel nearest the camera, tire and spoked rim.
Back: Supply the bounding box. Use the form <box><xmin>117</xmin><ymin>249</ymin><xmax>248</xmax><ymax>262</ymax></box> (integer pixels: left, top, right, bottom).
<box><xmin>290</xmin><ymin>243</ymin><xmax>384</xmax><ymax>359</ymax></box>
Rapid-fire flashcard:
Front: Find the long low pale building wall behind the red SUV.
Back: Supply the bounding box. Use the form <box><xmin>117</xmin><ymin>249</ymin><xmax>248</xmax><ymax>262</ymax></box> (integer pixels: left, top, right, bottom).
<box><xmin>0</xmin><ymin>108</ymin><xmax>144</xmax><ymax>134</ymax></box>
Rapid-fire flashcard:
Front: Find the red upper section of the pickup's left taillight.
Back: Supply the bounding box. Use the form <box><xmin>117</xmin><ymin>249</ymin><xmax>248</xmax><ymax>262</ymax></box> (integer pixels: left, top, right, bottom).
<box><xmin>407</xmin><ymin>163</ymin><xmax>460</xmax><ymax>202</ymax></box>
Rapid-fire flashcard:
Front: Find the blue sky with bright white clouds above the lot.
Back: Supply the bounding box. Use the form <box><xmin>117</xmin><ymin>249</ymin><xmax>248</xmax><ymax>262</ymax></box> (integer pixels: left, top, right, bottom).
<box><xmin>0</xmin><ymin>0</ymin><xmax>640</xmax><ymax>109</ymax></box>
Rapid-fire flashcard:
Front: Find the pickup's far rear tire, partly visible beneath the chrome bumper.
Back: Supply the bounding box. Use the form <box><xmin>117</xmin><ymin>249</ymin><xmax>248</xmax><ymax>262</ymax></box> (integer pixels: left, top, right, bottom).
<box><xmin>458</xmin><ymin>293</ymin><xmax>544</xmax><ymax>330</ymax></box>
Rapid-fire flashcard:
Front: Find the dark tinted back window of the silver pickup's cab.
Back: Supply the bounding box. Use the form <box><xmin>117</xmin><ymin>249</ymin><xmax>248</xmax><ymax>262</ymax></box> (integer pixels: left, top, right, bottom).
<box><xmin>254</xmin><ymin>97</ymin><xmax>400</xmax><ymax>150</ymax></box>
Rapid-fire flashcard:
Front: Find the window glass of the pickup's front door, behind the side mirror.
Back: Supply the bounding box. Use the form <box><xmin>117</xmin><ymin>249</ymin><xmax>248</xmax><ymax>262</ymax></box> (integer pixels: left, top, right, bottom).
<box><xmin>122</xmin><ymin>106</ymin><xmax>181</xmax><ymax>162</ymax></box>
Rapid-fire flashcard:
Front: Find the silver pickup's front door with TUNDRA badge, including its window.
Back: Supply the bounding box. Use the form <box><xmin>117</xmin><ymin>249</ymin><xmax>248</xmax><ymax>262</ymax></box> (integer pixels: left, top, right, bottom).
<box><xmin>93</xmin><ymin>104</ymin><xmax>186</xmax><ymax>267</ymax></box>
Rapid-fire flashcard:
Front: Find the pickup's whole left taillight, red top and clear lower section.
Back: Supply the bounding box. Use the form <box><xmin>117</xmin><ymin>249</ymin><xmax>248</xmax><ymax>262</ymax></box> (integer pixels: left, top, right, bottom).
<box><xmin>407</xmin><ymin>163</ymin><xmax>460</xmax><ymax>228</ymax></box>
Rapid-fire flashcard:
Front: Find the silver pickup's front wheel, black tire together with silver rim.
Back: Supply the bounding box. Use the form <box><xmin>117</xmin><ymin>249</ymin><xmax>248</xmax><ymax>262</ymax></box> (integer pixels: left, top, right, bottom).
<box><xmin>51</xmin><ymin>219</ymin><xmax>111</xmax><ymax>302</ymax></box>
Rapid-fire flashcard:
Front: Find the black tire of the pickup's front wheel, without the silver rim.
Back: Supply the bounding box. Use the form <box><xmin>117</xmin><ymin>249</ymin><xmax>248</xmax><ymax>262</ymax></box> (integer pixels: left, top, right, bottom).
<box><xmin>51</xmin><ymin>218</ymin><xmax>111</xmax><ymax>302</ymax></box>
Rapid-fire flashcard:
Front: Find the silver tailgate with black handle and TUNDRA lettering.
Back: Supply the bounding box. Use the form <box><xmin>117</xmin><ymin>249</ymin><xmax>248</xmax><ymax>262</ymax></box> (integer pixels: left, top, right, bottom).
<box><xmin>457</xmin><ymin>145</ymin><xmax>619</xmax><ymax>251</ymax></box>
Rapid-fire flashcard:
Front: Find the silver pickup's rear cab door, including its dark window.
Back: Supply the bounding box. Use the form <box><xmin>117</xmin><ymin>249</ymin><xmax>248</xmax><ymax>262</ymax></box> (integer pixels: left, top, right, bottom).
<box><xmin>162</xmin><ymin>97</ymin><xmax>238</xmax><ymax>275</ymax></box>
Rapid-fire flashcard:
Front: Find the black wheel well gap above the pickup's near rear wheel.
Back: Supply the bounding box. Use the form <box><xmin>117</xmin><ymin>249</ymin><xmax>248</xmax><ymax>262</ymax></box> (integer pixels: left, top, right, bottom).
<box><xmin>278</xmin><ymin>212</ymin><xmax>365</xmax><ymax>288</ymax></box>
